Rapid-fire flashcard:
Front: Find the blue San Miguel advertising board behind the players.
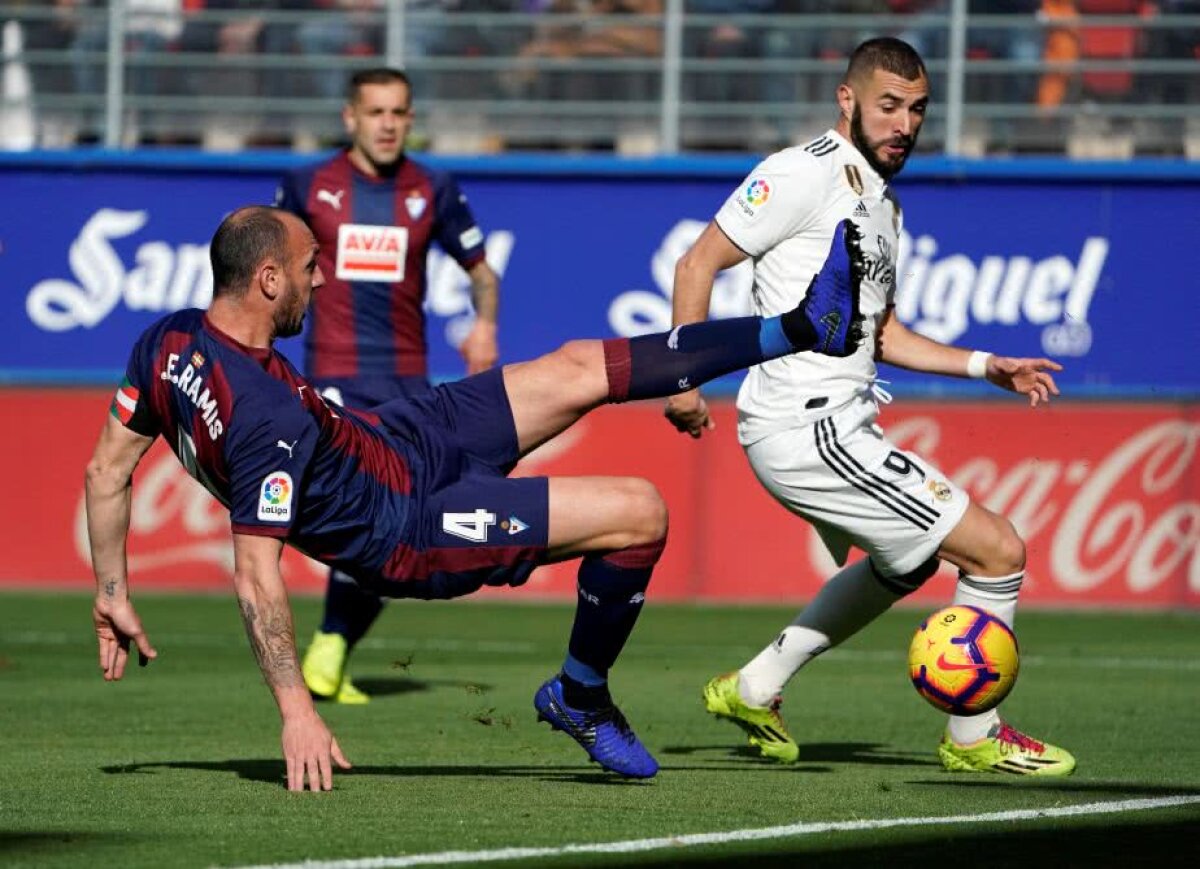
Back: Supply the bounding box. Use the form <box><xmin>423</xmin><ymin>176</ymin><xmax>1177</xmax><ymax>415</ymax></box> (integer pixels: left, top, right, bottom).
<box><xmin>0</xmin><ymin>160</ymin><xmax>1200</xmax><ymax>400</ymax></box>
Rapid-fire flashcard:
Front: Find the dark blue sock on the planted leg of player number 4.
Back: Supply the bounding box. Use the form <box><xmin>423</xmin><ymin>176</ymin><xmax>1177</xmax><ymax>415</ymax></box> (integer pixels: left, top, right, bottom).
<box><xmin>563</xmin><ymin>539</ymin><xmax>666</xmax><ymax>688</ymax></box>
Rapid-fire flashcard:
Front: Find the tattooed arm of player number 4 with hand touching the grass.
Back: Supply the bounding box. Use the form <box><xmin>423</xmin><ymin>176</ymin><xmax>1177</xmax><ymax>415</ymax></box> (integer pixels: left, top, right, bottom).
<box><xmin>233</xmin><ymin>534</ymin><xmax>350</xmax><ymax>791</ymax></box>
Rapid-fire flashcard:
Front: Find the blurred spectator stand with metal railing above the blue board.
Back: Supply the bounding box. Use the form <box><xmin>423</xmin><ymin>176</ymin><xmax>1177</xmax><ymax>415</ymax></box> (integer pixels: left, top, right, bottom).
<box><xmin>0</xmin><ymin>0</ymin><xmax>1200</xmax><ymax>157</ymax></box>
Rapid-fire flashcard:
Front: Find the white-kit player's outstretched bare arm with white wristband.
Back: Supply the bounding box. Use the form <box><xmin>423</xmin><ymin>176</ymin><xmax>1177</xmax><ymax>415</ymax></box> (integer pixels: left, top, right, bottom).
<box><xmin>878</xmin><ymin>308</ymin><xmax>1062</xmax><ymax>407</ymax></box>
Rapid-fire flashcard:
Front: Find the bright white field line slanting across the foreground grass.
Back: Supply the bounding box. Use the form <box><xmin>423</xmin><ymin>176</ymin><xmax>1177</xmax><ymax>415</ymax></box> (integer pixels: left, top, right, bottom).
<box><xmin>223</xmin><ymin>796</ymin><xmax>1200</xmax><ymax>869</ymax></box>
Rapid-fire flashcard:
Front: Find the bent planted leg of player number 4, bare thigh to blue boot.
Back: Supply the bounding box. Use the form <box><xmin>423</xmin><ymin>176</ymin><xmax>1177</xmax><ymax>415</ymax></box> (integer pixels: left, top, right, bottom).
<box><xmin>534</xmin><ymin>477</ymin><xmax>667</xmax><ymax>778</ymax></box>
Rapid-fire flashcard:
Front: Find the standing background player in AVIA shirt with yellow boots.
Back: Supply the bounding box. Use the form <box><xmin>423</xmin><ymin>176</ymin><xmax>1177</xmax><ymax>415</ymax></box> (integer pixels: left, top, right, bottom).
<box><xmin>276</xmin><ymin>68</ymin><xmax>499</xmax><ymax>703</ymax></box>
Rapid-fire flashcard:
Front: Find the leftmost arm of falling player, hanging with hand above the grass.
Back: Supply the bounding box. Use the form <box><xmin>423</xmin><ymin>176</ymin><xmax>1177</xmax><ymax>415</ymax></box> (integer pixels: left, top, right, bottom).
<box><xmin>84</xmin><ymin>416</ymin><xmax>158</xmax><ymax>682</ymax></box>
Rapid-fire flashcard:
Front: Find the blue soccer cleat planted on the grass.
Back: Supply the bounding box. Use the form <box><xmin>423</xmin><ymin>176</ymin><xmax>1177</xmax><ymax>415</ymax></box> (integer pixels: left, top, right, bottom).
<box><xmin>533</xmin><ymin>676</ymin><xmax>659</xmax><ymax>779</ymax></box>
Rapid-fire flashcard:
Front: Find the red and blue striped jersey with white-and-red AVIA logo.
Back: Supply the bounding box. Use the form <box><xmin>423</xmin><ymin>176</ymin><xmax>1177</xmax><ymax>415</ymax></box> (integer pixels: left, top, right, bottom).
<box><xmin>275</xmin><ymin>151</ymin><xmax>485</xmax><ymax>379</ymax></box>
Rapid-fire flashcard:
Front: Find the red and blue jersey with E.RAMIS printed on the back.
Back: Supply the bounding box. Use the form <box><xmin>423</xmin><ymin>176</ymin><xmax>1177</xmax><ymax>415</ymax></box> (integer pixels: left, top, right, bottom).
<box><xmin>113</xmin><ymin>308</ymin><xmax>422</xmax><ymax>577</ymax></box>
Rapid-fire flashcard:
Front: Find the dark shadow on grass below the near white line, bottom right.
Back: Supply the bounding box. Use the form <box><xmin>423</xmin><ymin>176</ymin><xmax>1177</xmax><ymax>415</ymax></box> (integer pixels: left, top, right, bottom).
<box><xmin>604</xmin><ymin>819</ymin><xmax>1200</xmax><ymax>869</ymax></box>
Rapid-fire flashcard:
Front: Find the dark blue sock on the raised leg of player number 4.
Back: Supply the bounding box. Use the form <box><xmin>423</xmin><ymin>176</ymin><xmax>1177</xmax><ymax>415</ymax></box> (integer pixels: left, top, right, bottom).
<box><xmin>604</xmin><ymin>308</ymin><xmax>817</xmax><ymax>402</ymax></box>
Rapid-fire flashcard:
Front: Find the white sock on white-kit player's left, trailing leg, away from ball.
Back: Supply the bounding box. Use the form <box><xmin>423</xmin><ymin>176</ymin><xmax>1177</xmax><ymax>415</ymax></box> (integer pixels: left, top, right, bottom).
<box><xmin>738</xmin><ymin>558</ymin><xmax>902</xmax><ymax>706</ymax></box>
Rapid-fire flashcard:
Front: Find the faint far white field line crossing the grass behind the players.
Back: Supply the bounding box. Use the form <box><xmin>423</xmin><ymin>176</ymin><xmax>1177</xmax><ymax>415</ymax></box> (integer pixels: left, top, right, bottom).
<box><xmin>0</xmin><ymin>629</ymin><xmax>1200</xmax><ymax>672</ymax></box>
